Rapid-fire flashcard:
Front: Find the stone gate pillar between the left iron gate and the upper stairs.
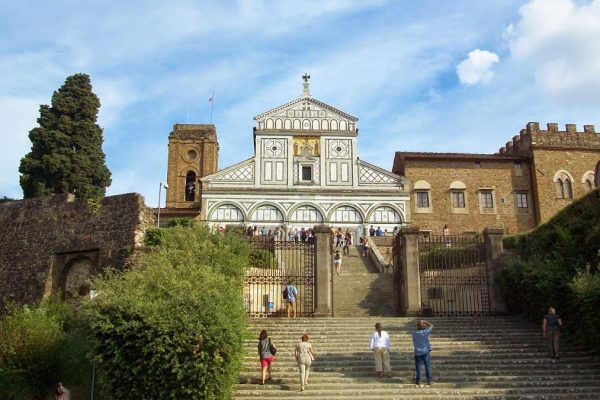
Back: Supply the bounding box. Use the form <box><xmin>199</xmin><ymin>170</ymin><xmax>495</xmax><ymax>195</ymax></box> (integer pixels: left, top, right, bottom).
<box><xmin>313</xmin><ymin>225</ymin><xmax>333</xmax><ymax>317</ymax></box>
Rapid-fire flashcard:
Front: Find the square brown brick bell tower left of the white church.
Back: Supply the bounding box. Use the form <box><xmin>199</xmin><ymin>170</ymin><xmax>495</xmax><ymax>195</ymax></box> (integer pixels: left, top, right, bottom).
<box><xmin>166</xmin><ymin>124</ymin><xmax>219</xmax><ymax>209</ymax></box>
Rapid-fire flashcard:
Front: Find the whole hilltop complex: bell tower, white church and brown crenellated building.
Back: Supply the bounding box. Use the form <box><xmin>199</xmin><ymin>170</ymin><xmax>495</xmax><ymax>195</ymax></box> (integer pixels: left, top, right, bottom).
<box><xmin>160</xmin><ymin>75</ymin><xmax>600</xmax><ymax>237</ymax></box>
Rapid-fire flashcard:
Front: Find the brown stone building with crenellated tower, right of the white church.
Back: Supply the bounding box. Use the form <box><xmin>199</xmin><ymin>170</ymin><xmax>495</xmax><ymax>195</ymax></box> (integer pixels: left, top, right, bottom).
<box><xmin>392</xmin><ymin>122</ymin><xmax>600</xmax><ymax>234</ymax></box>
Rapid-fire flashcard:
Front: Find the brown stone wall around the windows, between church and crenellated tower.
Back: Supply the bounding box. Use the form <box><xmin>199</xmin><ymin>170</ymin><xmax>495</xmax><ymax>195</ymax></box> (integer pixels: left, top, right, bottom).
<box><xmin>404</xmin><ymin>159</ymin><xmax>536</xmax><ymax>234</ymax></box>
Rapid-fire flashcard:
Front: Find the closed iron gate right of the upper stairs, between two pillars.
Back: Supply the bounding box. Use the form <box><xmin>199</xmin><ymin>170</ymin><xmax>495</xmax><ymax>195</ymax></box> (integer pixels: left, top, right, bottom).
<box><xmin>419</xmin><ymin>235</ymin><xmax>490</xmax><ymax>316</ymax></box>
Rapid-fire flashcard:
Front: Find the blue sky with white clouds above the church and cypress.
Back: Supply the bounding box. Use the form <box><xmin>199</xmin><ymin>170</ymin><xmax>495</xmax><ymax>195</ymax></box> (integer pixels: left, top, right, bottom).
<box><xmin>0</xmin><ymin>0</ymin><xmax>600</xmax><ymax>207</ymax></box>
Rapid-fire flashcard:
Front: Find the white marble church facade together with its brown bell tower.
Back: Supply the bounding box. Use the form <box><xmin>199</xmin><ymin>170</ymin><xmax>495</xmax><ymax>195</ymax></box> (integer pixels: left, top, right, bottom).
<box><xmin>161</xmin><ymin>75</ymin><xmax>410</xmax><ymax>235</ymax></box>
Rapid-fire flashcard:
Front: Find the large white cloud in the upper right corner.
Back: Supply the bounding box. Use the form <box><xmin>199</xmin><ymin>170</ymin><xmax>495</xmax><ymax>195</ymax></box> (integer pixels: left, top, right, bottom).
<box><xmin>508</xmin><ymin>0</ymin><xmax>600</xmax><ymax>103</ymax></box>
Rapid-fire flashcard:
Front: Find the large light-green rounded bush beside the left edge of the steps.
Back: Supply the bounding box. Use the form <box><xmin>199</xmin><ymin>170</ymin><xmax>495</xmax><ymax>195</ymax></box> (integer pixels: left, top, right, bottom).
<box><xmin>85</xmin><ymin>225</ymin><xmax>249</xmax><ymax>400</ymax></box>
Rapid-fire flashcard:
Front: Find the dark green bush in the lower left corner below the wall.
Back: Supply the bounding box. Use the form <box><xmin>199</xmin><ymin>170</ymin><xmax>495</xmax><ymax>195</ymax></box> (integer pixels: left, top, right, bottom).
<box><xmin>0</xmin><ymin>300</ymin><xmax>91</xmax><ymax>400</ymax></box>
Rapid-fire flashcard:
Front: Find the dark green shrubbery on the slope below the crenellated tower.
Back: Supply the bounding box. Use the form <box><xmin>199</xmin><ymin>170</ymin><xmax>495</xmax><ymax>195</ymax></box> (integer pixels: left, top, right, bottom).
<box><xmin>500</xmin><ymin>190</ymin><xmax>600</xmax><ymax>353</ymax></box>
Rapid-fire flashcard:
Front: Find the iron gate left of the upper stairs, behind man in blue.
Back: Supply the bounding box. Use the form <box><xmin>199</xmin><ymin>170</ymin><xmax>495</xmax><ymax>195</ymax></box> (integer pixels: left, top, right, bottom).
<box><xmin>244</xmin><ymin>236</ymin><xmax>315</xmax><ymax>317</ymax></box>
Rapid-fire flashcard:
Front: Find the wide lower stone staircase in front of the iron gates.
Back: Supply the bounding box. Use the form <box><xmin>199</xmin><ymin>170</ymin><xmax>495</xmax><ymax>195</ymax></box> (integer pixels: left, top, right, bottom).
<box><xmin>234</xmin><ymin>317</ymin><xmax>600</xmax><ymax>400</ymax></box>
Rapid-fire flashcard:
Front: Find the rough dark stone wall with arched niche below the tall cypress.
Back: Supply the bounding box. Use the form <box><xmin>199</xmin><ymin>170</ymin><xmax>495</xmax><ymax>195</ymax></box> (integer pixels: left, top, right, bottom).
<box><xmin>0</xmin><ymin>193</ymin><xmax>154</xmax><ymax>309</ymax></box>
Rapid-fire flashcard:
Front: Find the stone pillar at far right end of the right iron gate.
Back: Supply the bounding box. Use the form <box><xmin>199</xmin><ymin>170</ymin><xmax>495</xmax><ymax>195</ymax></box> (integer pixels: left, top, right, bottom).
<box><xmin>483</xmin><ymin>227</ymin><xmax>507</xmax><ymax>315</ymax></box>
